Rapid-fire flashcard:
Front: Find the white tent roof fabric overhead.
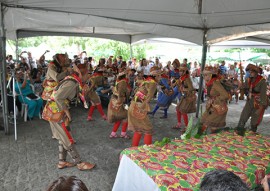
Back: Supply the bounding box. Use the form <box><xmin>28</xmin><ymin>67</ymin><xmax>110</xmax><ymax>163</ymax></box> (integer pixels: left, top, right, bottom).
<box><xmin>1</xmin><ymin>0</ymin><xmax>270</xmax><ymax>45</ymax></box>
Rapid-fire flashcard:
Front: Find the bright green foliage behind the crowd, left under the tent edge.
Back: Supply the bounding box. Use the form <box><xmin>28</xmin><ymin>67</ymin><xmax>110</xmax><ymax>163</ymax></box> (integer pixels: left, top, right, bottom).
<box><xmin>8</xmin><ymin>36</ymin><xmax>152</xmax><ymax>61</ymax></box>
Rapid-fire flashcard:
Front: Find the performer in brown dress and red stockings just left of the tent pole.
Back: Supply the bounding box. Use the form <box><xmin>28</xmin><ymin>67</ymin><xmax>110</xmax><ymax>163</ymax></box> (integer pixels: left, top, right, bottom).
<box><xmin>173</xmin><ymin>64</ymin><xmax>196</xmax><ymax>132</ymax></box>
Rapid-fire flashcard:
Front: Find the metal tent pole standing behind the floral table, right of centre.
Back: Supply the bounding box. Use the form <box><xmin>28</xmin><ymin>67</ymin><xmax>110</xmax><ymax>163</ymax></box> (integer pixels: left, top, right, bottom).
<box><xmin>196</xmin><ymin>30</ymin><xmax>207</xmax><ymax>118</ymax></box>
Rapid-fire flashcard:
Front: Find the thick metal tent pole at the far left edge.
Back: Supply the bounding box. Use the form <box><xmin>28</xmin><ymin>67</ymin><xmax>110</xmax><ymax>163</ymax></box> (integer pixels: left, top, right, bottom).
<box><xmin>0</xmin><ymin>3</ymin><xmax>9</xmax><ymax>134</ymax></box>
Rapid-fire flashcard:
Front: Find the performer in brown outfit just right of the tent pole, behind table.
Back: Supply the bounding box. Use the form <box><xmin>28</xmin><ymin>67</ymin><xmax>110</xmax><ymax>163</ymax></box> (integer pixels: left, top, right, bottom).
<box><xmin>201</xmin><ymin>66</ymin><xmax>229</xmax><ymax>133</ymax></box>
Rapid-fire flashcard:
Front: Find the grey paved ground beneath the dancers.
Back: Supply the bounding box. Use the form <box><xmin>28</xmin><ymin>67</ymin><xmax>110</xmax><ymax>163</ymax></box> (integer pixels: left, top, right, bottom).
<box><xmin>0</xmin><ymin>102</ymin><xmax>270</xmax><ymax>191</ymax></box>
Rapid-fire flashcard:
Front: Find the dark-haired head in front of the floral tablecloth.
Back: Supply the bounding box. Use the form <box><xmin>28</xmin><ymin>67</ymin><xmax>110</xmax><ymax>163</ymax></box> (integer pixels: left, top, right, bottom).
<box><xmin>200</xmin><ymin>169</ymin><xmax>250</xmax><ymax>191</ymax></box>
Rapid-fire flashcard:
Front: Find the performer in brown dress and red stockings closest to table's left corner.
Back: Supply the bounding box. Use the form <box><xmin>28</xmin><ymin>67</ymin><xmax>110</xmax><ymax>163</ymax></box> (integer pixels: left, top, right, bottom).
<box><xmin>128</xmin><ymin>67</ymin><xmax>160</xmax><ymax>146</ymax></box>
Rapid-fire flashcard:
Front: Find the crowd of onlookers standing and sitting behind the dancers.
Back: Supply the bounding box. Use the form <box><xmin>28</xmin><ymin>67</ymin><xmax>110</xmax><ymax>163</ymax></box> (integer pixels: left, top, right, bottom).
<box><xmin>3</xmin><ymin>50</ymin><xmax>270</xmax><ymax>117</ymax></box>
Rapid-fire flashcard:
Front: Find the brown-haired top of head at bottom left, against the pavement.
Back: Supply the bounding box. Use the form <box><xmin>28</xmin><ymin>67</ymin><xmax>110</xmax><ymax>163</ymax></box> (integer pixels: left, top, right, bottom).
<box><xmin>47</xmin><ymin>176</ymin><xmax>89</xmax><ymax>191</ymax></box>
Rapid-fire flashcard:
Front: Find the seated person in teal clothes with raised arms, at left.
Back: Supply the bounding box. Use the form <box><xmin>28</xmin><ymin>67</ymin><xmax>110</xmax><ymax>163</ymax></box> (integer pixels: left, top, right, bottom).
<box><xmin>15</xmin><ymin>71</ymin><xmax>43</xmax><ymax>119</ymax></box>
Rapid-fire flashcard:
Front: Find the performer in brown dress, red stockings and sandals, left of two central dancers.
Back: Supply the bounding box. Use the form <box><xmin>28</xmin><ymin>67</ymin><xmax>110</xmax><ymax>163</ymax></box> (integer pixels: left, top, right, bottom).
<box><xmin>108</xmin><ymin>68</ymin><xmax>131</xmax><ymax>139</ymax></box>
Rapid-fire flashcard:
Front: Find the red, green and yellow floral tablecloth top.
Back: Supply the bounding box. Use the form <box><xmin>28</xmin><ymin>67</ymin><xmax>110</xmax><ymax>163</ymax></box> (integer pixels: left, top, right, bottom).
<box><xmin>121</xmin><ymin>132</ymin><xmax>270</xmax><ymax>191</ymax></box>
